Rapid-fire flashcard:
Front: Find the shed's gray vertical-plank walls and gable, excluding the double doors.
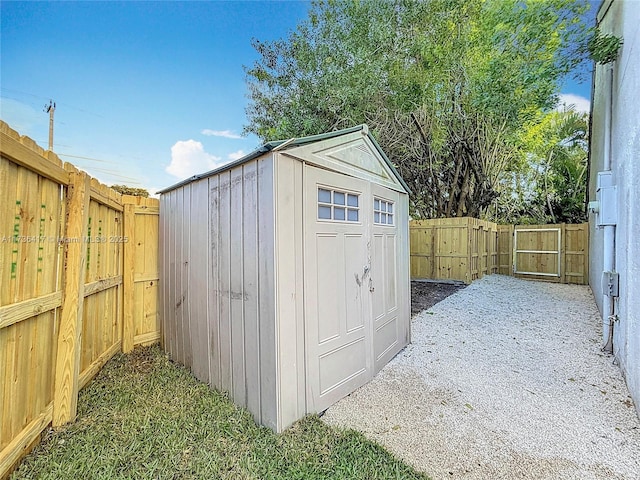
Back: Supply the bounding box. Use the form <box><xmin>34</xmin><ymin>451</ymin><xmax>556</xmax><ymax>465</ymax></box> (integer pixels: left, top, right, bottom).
<box><xmin>160</xmin><ymin>132</ymin><xmax>410</xmax><ymax>431</ymax></box>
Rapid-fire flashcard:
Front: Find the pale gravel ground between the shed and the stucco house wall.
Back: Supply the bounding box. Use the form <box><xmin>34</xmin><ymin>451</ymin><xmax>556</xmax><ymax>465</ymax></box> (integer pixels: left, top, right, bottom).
<box><xmin>323</xmin><ymin>275</ymin><xmax>640</xmax><ymax>480</ymax></box>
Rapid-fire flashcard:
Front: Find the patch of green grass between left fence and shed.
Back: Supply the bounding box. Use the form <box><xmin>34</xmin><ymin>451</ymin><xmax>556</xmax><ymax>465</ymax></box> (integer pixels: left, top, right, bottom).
<box><xmin>11</xmin><ymin>346</ymin><xmax>427</xmax><ymax>480</ymax></box>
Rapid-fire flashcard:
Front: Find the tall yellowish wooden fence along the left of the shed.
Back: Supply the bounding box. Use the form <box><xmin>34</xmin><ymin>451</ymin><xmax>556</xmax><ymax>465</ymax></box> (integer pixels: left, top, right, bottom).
<box><xmin>0</xmin><ymin>122</ymin><xmax>160</xmax><ymax>478</ymax></box>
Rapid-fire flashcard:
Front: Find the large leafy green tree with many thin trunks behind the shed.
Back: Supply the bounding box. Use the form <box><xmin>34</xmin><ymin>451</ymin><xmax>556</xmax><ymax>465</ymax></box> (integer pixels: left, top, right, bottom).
<box><xmin>245</xmin><ymin>0</ymin><xmax>587</xmax><ymax>217</ymax></box>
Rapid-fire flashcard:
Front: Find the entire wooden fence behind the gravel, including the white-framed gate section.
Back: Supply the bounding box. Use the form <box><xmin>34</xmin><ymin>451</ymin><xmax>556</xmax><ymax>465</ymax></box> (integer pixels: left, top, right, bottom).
<box><xmin>409</xmin><ymin>217</ymin><xmax>589</xmax><ymax>285</ymax></box>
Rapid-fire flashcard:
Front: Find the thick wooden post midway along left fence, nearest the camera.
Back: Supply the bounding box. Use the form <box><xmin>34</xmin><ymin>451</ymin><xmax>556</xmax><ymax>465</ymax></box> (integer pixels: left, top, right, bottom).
<box><xmin>53</xmin><ymin>164</ymin><xmax>91</xmax><ymax>427</ymax></box>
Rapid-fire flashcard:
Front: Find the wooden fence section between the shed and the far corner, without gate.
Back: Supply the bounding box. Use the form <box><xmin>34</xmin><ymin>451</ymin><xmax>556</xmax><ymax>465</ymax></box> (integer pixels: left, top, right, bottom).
<box><xmin>409</xmin><ymin>217</ymin><xmax>498</xmax><ymax>283</ymax></box>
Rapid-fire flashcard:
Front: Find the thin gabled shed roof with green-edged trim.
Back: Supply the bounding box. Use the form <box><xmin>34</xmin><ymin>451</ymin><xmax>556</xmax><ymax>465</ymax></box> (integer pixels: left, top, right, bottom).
<box><xmin>158</xmin><ymin>124</ymin><xmax>410</xmax><ymax>194</ymax></box>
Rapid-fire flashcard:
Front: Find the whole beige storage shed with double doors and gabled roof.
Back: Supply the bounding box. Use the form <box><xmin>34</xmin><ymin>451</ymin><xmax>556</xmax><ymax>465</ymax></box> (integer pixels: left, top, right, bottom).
<box><xmin>160</xmin><ymin>125</ymin><xmax>410</xmax><ymax>432</ymax></box>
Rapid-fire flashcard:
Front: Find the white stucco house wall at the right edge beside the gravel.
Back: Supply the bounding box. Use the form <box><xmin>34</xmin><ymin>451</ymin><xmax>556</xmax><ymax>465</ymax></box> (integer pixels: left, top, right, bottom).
<box><xmin>589</xmin><ymin>0</ymin><xmax>640</xmax><ymax>413</ymax></box>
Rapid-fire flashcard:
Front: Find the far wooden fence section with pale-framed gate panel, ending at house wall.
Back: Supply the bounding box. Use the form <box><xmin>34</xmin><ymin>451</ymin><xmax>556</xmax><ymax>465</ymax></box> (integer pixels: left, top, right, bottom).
<box><xmin>498</xmin><ymin>223</ymin><xmax>589</xmax><ymax>285</ymax></box>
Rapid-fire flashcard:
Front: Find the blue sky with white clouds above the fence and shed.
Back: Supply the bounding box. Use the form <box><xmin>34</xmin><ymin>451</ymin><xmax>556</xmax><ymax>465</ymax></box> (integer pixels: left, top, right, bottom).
<box><xmin>0</xmin><ymin>1</ymin><xmax>590</xmax><ymax>192</ymax></box>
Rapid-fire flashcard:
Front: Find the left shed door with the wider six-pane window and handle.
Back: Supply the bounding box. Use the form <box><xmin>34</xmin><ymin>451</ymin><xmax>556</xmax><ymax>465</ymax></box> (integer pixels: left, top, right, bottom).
<box><xmin>304</xmin><ymin>165</ymin><xmax>373</xmax><ymax>412</ymax></box>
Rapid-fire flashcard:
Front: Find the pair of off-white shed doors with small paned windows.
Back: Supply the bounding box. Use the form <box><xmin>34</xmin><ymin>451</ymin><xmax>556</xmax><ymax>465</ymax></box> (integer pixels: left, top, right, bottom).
<box><xmin>304</xmin><ymin>165</ymin><xmax>404</xmax><ymax>412</ymax></box>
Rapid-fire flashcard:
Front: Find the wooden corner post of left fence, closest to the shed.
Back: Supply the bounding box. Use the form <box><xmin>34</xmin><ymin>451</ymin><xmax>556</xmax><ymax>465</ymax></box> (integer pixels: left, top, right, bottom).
<box><xmin>122</xmin><ymin>200</ymin><xmax>136</xmax><ymax>353</ymax></box>
